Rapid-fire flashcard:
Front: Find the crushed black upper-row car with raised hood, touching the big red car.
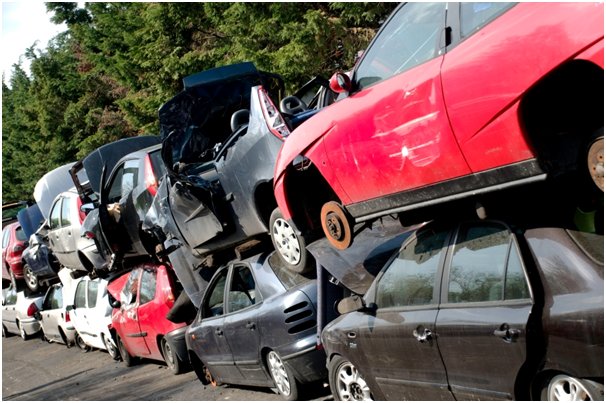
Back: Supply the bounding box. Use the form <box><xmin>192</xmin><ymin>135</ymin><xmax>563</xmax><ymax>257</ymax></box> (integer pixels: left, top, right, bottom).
<box><xmin>147</xmin><ymin>63</ymin><xmax>334</xmax><ymax>305</ymax></box>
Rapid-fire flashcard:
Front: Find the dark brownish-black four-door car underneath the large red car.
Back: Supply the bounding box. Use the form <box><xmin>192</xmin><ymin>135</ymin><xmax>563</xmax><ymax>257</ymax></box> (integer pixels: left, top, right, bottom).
<box><xmin>322</xmin><ymin>220</ymin><xmax>604</xmax><ymax>400</ymax></box>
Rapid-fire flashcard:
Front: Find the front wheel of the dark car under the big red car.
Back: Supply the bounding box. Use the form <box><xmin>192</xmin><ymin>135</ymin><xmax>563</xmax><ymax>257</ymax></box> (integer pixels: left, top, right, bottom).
<box><xmin>328</xmin><ymin>357</ymin><xmax>373</xmax><ymax>401</ymax></box>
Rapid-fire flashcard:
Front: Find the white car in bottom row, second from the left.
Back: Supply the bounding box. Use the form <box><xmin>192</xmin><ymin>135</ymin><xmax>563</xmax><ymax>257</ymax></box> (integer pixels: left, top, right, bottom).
<box><xmin>34</xmin><ymin>284</ymin><xmax>76</xmax><ymax>347</ymax></box>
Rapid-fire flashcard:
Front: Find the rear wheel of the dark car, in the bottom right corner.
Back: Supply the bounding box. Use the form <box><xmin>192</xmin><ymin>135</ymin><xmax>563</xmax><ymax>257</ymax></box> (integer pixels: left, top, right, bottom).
<box><xmin>541</xmin><ymin>375</ymin><xmax>604</xmax><ymax>401</ymax></box>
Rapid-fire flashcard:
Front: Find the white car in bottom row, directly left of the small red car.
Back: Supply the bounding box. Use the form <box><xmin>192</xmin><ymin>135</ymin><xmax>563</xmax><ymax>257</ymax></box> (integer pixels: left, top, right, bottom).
<box><xmin>59</xmin><ymin>269</ymin><xmax>120</xmax><ymax>360</ymax></box>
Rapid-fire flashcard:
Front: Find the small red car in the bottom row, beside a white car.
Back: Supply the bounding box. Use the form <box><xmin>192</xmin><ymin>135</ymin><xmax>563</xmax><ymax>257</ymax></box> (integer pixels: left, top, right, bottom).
<box><xmin>108</xmin><ymin>263</ymin><xmax>189</xmax><ymax>374</ymax></box>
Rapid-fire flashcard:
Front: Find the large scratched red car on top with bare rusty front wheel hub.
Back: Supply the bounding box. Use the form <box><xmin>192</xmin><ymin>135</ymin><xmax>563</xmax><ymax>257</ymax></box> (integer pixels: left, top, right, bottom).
<box><xmin>274</xmin><ymin>2</ymin><xmax>604</xmax><ymax>254</ymax></box>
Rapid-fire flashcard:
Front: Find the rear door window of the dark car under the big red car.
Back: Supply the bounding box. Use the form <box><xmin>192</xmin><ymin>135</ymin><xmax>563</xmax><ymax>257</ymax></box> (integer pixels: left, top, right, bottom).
<box><xmin>448</xmin><ymin>223</ymin><xmax>528</xmax><ymax>302</ymax></box>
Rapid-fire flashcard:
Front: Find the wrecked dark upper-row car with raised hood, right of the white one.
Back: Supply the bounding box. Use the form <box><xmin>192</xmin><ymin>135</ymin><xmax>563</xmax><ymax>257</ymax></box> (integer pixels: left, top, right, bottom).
<box><xmin>70</xmin><ymin>136</ymin><xmax>165</xmax><ymax>277</ymax></box>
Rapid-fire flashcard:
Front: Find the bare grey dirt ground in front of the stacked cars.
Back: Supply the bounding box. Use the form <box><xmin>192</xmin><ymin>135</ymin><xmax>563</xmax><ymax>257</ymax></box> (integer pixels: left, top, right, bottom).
<box><xmin>2</xmin><ymin>336</ymin><xmax>332</xmax><ymax>401</ymax></box>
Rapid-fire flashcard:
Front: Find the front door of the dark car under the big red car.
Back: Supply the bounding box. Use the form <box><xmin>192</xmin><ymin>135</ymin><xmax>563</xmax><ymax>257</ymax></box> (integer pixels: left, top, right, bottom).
<box><xmin>356</xmin><ymin>229</ymin><xmax>453</xmax><ymax>400</ymax></box>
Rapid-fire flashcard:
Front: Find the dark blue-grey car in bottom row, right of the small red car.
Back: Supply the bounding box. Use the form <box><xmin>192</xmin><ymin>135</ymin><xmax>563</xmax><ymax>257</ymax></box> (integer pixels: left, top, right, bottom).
<box><xmin>186</xmin><ymin>253</ymin><xmax>326</xmax><ymax>400</ymax></box>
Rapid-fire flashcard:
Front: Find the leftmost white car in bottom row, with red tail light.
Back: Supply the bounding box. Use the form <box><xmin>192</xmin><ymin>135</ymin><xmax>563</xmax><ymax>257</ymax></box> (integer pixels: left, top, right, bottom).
<box><xmin>2</xmin><ymin>285</ymin><xmax>44</xmax><ymax>340</ymax></box>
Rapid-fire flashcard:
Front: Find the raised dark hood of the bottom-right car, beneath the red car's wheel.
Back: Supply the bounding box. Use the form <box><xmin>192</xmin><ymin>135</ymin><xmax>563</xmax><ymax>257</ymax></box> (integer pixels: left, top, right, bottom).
<box><xmin>307</xmin><ymin>217</ymin><xmax>413</xmax><ymax>295</ymax></box>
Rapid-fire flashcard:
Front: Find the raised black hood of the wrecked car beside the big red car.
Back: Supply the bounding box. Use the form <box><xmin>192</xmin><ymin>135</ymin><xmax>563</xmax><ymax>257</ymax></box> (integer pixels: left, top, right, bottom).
<box><xmin>158</xmin><ymin>62</ymin><xmax>284</xmax><ymax>172</ymax></box>
